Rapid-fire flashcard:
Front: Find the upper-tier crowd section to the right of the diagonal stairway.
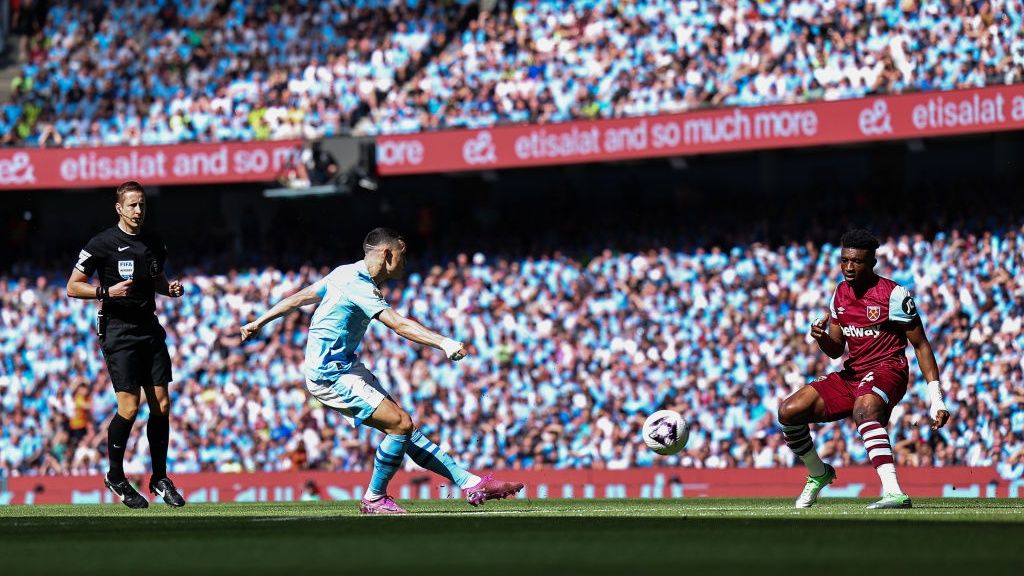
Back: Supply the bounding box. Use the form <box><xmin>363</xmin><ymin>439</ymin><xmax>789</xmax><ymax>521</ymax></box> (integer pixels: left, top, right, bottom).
<box><xmin>360</xmin><ymin>0</ymin><xmax>1024</xmax><ymax>133</ymax></box>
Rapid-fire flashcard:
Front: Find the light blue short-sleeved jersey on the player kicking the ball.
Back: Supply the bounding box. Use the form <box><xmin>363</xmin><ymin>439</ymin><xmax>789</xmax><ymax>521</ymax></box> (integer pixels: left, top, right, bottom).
<box><xmin>305</xmin><ymin>260</ymin><xmax>390</xmax><ymax>382</ymax></box>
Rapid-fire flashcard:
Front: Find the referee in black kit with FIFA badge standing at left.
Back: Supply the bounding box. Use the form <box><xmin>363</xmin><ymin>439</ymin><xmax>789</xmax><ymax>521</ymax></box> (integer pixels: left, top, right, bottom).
<box><xmin>68</xmin><ymin>181</ymin><xmax>185</xmax><ymax>508</ymax></box>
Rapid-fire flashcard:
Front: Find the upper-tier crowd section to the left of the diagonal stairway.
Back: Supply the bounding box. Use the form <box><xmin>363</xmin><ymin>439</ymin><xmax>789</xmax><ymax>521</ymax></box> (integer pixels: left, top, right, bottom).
<box><xmin>0</xmin><ymin>0</ymin><xmax>467</xmax><ymax>147</ymax></box>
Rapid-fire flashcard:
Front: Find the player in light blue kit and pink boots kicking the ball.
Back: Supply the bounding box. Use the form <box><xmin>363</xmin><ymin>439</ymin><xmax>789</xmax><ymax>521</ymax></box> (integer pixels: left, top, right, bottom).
<box><xmin>242</xmin><ymin>228</ymin><xmax>523</xmax><ymax>513</ymax></box>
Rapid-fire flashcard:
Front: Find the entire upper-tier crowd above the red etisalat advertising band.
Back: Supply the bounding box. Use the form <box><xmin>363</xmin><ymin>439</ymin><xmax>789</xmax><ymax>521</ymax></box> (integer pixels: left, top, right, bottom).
<box><xmin>6</xmin><ymin>0</ymin><xmax>1024</xmax><ymax>142</ymax></box>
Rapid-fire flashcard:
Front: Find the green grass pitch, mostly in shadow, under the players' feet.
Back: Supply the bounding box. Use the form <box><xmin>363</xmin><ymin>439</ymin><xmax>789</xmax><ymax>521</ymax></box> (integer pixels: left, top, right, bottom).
<box><xmin>0</xmin><ymin>498</ymin><xmax>1024</xmax><ymax>576</ymax></box>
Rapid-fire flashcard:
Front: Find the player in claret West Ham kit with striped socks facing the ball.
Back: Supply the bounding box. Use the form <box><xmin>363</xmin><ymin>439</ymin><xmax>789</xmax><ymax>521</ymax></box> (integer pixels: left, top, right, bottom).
<box><xmin>778</xmin><ymin>230</ymin><xmax>949</xmax><ymax>509</ymax></box>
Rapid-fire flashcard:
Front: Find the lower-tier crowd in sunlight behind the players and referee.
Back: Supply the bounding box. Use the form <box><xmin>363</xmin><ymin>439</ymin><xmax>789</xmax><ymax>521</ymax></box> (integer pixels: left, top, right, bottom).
<box><xmin>0</xmin><ymin>224</ymin><xmax>1024</xmax><ymax>478</ymax></box>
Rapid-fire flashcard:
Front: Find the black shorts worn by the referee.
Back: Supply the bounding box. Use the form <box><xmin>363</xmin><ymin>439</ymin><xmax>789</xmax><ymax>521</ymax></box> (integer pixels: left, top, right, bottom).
<box><xmin>99</xmin><ymin>316</ymin><xmax>172</xmax><ymax>394</ymax></box>
